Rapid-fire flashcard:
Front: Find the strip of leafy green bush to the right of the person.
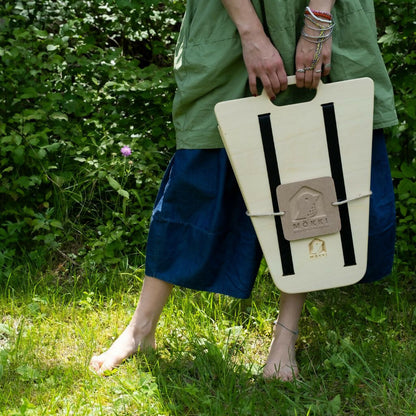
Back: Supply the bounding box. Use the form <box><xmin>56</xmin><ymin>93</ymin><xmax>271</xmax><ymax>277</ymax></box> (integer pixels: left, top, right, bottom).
<box><xmin>375</xmin><ymin>0</ymin><xmax>416</xmax><ymax>272</ymax></box>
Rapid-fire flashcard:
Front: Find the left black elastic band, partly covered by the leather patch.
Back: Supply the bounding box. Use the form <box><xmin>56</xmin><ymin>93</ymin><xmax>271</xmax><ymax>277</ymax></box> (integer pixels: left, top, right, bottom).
<box><xmin>258</xmin><ymin>114</ymin><xmax>295</xmax><ymax>276</ymax></box>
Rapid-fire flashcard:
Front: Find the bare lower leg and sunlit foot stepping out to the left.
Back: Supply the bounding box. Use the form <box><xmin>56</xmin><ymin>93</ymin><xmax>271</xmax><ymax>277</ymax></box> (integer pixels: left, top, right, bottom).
<box><xmin>90</xmin><ymin>276</ymin><xmax>173</xmax><ymax>374</ymax></box>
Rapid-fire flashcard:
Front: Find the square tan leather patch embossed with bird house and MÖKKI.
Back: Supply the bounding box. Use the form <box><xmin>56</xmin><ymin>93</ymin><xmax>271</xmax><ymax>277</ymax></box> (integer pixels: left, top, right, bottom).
<box><xmin>277</xmin><ymin>177</ymin><xmax>341</xmax><ymax>241</ymax></box>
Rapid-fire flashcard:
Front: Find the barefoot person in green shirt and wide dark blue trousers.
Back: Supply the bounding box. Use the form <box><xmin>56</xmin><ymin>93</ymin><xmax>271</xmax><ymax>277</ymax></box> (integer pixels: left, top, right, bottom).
<box><xmin>90</xmin><ymin>0</ymin><xmax>397</xmax><ymax>380</ymax></box>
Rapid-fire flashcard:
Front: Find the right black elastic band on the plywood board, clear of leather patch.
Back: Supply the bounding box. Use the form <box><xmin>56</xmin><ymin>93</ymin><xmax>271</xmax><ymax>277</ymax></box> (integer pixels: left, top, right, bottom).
<box><xmin>322</xmin><ymin>103</ymin><xmax>357</xmax><ymax>266</ymax></box>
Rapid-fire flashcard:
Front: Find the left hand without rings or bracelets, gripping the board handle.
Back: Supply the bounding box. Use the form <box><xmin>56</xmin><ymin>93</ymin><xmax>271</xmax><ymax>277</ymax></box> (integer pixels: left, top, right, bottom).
<box><xmin>241</xmin><ymin>33</ymin><xmax>287</xmax><ymax>99</ymax></box>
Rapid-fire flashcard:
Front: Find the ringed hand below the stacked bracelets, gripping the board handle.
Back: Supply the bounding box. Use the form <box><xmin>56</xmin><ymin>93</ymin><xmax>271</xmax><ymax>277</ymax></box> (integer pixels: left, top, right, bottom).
<box><xmin>296</xmin><ymin>22</ymin><xmax>332</xmax><ymax>88</ymax></box>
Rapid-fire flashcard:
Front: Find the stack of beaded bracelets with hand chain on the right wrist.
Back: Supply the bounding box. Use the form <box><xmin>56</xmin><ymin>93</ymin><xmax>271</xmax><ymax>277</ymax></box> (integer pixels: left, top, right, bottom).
<box><xmin>296</xmin><ymin>7</ymin><xmax>335</xmax><ymax>72</ymax></box>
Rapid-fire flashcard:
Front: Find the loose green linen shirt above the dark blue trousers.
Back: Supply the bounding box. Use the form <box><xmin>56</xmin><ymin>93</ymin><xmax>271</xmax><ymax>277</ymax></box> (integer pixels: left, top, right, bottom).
<box><xmin>172</xmin><ymin>0</ymin><xmax>397</xmax><ymax>149</ymax></box>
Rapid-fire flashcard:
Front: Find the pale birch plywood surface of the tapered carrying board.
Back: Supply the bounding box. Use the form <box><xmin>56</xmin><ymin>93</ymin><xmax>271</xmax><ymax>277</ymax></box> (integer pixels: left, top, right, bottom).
<box><xmin>215</xmin><ymin>76</ymin><xmax>374</xmax><ymax>293</ymax></box>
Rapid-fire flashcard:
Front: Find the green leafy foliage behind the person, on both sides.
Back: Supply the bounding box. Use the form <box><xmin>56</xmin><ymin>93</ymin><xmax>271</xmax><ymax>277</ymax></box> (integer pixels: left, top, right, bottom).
<box><xmin>0</xmin><ymin>0</ymin><xmax>416</xmax><ymax>277</ymax></box>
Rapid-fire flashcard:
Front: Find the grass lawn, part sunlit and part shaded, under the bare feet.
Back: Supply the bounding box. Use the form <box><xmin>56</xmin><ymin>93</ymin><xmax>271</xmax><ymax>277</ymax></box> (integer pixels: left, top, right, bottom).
<box><xmin>0</xmin><ymin>264</ymin><xmax>416</xmax><ymax>416</ymax></box>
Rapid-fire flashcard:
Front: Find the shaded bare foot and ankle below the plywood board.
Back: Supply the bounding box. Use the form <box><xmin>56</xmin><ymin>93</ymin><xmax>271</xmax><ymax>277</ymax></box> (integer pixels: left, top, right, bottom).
<box><xmin>263</xmin><ymin>325</ymin><xmax>299</xmax><ymax>381</ymax></box>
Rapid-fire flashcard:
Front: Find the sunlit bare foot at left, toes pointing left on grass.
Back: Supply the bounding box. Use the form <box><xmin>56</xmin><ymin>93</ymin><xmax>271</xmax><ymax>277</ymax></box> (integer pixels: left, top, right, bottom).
<box><xmin>90</xmin><ymin>325</ymin><xmax>156</xmax><ymax>375</ymax></box>
